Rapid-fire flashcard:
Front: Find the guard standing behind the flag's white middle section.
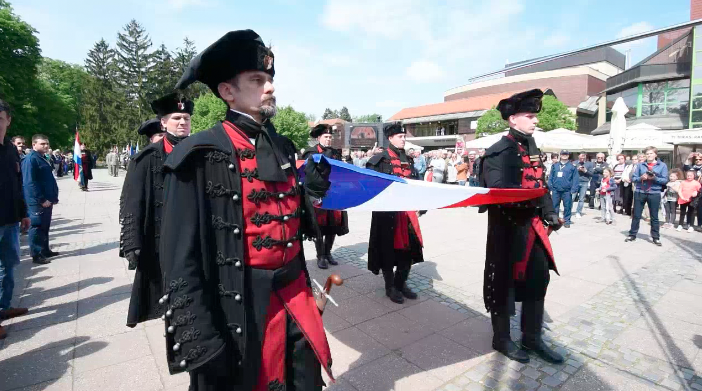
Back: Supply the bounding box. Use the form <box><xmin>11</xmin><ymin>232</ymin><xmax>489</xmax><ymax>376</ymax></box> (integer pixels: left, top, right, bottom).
<box><xmin>366</xmin><ymin>123</ymin><xmax>424</xmax><ymax>304</ymax></box>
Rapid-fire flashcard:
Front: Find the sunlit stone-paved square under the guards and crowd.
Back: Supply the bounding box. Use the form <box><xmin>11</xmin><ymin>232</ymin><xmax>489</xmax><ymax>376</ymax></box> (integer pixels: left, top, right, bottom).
<box><xmin>0</xmin><ymin>170</ymin><xmax>702</xmax><ymax>391</ymax></box>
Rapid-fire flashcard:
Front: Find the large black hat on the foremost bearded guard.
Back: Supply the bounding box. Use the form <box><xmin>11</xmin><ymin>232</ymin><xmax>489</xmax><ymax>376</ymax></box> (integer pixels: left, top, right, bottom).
<box><xmin>175</xmin><ymin>30</ymin><xmax>275</xmax><ymax>98</ymax></box>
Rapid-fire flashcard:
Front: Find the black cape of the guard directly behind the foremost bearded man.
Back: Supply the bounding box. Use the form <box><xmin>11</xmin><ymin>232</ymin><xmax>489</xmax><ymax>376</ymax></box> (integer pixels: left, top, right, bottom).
<box><xmin>119</xmin><ymin>140</ymin><xmax>166</xmax><ymax>327</ymax></box>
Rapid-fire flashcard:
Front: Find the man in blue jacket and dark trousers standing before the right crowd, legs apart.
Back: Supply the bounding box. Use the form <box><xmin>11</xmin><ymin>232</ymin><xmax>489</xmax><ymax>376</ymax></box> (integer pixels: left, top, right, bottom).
<box><xmin>625</xmin><ymin>147</ymin><xmax>668</xmax><ymax>246</ymax></box>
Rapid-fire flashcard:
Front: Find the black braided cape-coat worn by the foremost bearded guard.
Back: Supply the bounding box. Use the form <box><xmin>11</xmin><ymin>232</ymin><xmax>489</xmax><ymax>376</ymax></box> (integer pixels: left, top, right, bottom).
<box><xmin>160</xmin><ymin>123</ymin><xmax>317</xmax><ymax>390</ymax></box>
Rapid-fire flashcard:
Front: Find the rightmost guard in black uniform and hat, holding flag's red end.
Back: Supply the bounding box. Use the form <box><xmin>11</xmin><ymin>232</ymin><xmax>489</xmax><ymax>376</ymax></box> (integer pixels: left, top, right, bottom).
<box><xmin>480</xmin><ymin>90</ymin><xmax>563</xmax><ymax>363</ymax></box>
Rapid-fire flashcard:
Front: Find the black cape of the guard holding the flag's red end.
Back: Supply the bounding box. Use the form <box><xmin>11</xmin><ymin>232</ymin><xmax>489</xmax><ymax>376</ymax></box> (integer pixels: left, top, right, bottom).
<box><xmin>479</xmin><ymin>137</ymin><xmax>555</xmax><ymax>314</ymax></box>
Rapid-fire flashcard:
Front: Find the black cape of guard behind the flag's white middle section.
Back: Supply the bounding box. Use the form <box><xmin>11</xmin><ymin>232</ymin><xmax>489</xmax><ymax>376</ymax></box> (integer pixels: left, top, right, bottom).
<box><xmin>366</xmin><ymin>150</ymin><xmax>424</xmax><ymax>274</ymax></box>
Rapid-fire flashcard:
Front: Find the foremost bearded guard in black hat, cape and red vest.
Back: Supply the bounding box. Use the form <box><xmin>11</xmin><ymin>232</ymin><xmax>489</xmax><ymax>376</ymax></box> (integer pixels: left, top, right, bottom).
<box><xmin>160</xmin><ymin>30</ymin><xmax>333</xmax><ymax>391</ymax></box>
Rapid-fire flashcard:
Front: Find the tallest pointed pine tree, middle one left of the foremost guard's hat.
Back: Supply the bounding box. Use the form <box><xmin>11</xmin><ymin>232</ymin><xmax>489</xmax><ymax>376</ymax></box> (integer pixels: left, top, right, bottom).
<box><xmin>116</xmin><ymin>19</ymin><xmax>154</xmax><ymax>122</ymax></box>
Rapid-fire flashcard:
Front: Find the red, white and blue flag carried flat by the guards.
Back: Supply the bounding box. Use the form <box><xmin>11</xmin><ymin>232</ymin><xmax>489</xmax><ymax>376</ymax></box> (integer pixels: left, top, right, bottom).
<box><xmin>300</xmin><ymin>154</ymin><xmax>546</xmax><ymax>212</ymax></box>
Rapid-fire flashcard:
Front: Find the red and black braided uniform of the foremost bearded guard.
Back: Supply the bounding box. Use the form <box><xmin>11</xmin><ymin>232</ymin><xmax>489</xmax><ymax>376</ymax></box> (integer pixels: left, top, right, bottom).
<box><xmin>161</xmin><ymin>114</ymin><xmax>332</xmax><ymax>391</ymax></box>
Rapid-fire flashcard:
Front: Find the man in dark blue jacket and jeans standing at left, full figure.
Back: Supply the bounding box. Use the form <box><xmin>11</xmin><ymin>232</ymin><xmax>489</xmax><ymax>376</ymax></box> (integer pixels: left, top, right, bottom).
<box><xmin>22</xmin><ymin>134</ymin><xmax>58</xmax><ymax>265</ymax></box>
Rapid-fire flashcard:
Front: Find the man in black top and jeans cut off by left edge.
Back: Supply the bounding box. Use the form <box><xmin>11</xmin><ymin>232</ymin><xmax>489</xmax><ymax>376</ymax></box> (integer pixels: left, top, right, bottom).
<box><xmin>0</xmin><ymin>99</ymin><xmax>29</xmax><ymax>339</ymax></box>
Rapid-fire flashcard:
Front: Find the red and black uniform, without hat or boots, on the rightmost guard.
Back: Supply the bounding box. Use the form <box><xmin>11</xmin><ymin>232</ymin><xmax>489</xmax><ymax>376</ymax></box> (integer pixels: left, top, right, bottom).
<box><xmin>480</xmin><ymin>131</ymin><xmax>557</xmax><ymax>315</ymax></box>
